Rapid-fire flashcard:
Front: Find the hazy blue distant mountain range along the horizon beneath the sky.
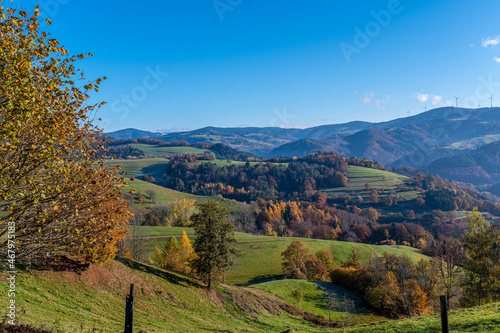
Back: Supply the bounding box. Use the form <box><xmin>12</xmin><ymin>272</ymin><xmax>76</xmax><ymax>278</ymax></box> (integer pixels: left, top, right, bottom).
<box><xmin>104</xmin><ymin>107</ymin><xmax>500</xmax><ymax>167</ymax></box>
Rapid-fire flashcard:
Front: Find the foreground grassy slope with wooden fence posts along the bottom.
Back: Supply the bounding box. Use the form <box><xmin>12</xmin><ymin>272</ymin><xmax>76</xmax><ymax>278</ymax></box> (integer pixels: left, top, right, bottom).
<box><xmin>4</xmin><ymin>259</ymin><xmax>500</xmax><ymax>333</ymax></box>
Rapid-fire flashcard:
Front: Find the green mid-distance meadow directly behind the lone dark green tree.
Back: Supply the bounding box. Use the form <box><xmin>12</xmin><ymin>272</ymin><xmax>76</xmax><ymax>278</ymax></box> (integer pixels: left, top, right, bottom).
<box><xmin>141</xmin><ymin>227</ymin><xmax>425</xmax><ymax>285</ymax></box>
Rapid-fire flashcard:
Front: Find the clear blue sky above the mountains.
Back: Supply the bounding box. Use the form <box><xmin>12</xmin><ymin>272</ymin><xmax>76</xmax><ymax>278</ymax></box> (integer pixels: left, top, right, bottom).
<box><xmin>14</xmin><ymin>0</ymin><xmax>500</xmax><ymax>131</ymax></box>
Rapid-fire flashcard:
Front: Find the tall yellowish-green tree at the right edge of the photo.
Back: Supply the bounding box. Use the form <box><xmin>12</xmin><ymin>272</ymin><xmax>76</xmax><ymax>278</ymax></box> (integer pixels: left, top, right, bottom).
<box><xmin>462</xmin><ymin>208</ymin><xmax>500</xmax><ymax>305</ymax></box>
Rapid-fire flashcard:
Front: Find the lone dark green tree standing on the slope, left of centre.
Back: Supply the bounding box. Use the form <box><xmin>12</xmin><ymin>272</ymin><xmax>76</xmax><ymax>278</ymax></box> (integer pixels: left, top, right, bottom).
<box><xmin>191</xmin><ymin>200</ymin><xmax>240</xmax><ymax>289</ymax></box>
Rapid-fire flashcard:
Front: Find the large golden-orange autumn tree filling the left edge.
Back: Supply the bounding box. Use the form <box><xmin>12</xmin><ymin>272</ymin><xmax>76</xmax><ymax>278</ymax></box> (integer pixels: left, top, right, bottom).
<box><xmin>0</xmin><ymin>7</ymin><xmax>130</xmax><ymax>266</ymax></box>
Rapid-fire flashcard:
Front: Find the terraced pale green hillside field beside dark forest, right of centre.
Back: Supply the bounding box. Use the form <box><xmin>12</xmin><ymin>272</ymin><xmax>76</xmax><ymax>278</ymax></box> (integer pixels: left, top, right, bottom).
<box><xmin>323</xmin><ymin>165</ymin><xmax>419</xmax><ymax>201</ymax></box>
